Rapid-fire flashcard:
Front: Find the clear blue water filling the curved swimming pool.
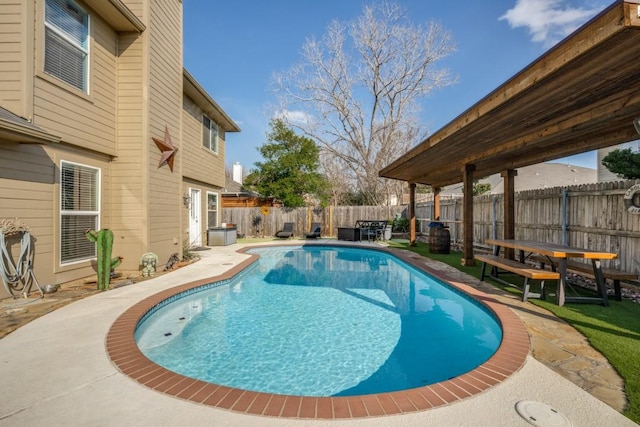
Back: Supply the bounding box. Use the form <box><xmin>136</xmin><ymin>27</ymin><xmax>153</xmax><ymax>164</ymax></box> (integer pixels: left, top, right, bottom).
<box><xmin>136</xmin><ymin>246</ymin><xmax>502</xmax><ymax>396</ymax></box>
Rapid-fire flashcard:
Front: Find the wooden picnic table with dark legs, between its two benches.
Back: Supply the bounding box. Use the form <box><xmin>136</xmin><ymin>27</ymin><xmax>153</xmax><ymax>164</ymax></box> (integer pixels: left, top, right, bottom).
<box><xmin>486</xmin><ymin>239</ymin><xmax>618</xmax><ymax>307</ymax></box>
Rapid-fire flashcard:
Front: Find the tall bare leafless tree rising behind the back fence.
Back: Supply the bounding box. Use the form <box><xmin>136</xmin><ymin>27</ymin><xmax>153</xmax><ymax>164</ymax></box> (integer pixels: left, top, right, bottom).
<box><xmin>274</xmin><ymin>3</ymin><xmax>454</xmax><ymax>204</ymax></box>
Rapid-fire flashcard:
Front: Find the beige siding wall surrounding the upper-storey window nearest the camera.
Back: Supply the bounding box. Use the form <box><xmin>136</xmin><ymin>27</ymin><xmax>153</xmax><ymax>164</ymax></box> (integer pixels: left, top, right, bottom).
<box><xmin>34</xmin><ymin>6</ymin><xmax>117</xmax><ymax>155</ymax></box>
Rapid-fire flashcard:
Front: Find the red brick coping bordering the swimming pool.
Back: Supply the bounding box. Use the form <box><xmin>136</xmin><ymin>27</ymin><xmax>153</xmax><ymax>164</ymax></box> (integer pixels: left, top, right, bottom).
<box><xmin>106</xmin><ymin>244</ymin><xmax>530</xmax><ymax>419</ymax></box>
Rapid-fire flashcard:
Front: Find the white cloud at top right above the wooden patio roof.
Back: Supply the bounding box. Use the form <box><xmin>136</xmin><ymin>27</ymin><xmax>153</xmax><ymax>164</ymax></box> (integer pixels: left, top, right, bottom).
<box><xmin>499</xmin><ymin>0</ymin><xmax>602</xmax><ymax>46</ymax></box>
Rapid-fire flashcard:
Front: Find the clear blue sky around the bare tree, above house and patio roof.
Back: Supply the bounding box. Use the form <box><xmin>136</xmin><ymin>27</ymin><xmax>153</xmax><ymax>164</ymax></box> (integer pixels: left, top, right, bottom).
<box><xmin>184</xmin><ymin>0</ymin><xmax>613</xmax><ymax>174</ymax></box>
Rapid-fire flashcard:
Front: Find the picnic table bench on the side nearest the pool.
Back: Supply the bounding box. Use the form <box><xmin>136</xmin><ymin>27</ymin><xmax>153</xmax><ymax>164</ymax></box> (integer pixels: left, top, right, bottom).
<box><xmin>475</xmin><ymin>255</ymin><xmax>560</xmax><ymax>302</ymax></box>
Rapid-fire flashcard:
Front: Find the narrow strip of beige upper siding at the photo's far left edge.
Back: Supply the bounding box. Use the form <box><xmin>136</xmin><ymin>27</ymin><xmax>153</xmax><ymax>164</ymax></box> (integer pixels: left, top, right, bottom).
<box><xmin>0</xmin><ymin>0</ymin><xmax>33</xmax><ymax>118</ymax></box>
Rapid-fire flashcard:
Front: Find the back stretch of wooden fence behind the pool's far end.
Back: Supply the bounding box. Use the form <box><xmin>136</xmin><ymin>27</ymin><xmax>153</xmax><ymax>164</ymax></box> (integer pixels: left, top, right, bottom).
<box><xmin>222</xmin><ymin>206</ymin><xmax>407</xmax><ymax>237</ymax></box>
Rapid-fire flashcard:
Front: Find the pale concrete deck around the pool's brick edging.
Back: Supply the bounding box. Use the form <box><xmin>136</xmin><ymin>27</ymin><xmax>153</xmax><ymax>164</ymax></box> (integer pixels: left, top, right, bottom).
<box><xmin>0</xmin><ymin>242</ymin><xmax>636</xmax><ymax>426</ymax></box>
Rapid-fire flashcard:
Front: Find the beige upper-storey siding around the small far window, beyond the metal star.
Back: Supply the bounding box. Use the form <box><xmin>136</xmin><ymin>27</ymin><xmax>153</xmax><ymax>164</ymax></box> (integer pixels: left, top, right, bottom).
<box><xmin>182</xmin><ymin>96</ymin><xmax>224</xmax><ymax>187</ymax></box>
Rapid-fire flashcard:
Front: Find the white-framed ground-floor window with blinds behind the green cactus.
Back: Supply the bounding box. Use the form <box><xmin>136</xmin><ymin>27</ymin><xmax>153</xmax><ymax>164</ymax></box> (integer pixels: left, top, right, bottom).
<box><xmin>60</xmin><ymin>161</ymin><xmax>100</xmax><ymax>264</ymax></box>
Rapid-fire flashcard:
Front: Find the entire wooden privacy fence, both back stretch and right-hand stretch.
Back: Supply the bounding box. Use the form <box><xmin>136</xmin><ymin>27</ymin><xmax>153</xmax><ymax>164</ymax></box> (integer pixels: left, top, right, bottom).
<box><xmin>222</xmin><ymin>180</ymin><xmax>640</xmax><ymax>274</ymax></box>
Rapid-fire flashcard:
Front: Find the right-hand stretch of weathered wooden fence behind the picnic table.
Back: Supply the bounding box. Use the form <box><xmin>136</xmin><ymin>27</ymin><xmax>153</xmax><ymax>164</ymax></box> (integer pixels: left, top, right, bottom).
<box><xmin>416</xmin><ymin>180</ymin><xmax>640</xmax><ymax>274</ymax></box>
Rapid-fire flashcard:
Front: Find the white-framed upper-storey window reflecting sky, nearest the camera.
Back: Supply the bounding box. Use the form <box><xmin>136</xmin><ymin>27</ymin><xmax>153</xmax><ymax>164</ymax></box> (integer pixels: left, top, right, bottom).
<box><xmin>44</xmin><ymin>0</ymin><xmax>89</xmax><ymax>92</ymax></box>
